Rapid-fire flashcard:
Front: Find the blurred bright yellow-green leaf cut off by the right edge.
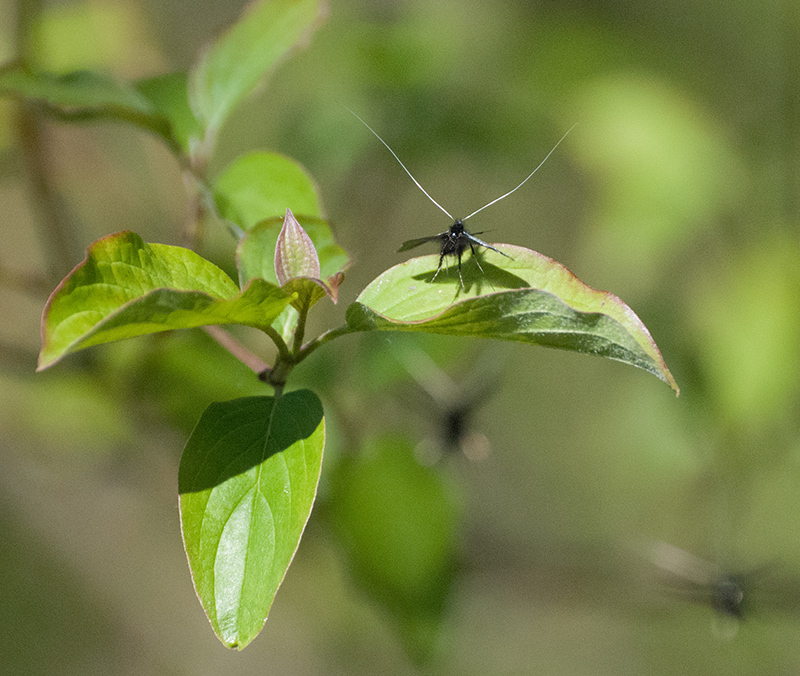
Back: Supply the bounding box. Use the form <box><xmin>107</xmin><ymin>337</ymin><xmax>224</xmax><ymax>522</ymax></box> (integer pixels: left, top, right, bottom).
<box><xmin>687</xmin><ymin>229</ymin><xmax>800</xmax><ymax>422</ymax></box>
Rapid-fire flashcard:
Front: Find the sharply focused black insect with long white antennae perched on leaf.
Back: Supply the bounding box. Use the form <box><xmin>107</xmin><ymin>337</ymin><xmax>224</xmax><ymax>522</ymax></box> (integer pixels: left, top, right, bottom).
<box><xmin>350</xmin><ymin>110</ymin><xmax>575</xmax><ymax>288</ymax></box>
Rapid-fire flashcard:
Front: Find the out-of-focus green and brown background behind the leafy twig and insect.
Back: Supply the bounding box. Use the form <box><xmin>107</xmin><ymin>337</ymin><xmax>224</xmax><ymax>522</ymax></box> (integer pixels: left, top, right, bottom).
<box><xmin>0</xmin><ymin>0</ymin><xmax>800</xmax><ymax>676</ymax></box>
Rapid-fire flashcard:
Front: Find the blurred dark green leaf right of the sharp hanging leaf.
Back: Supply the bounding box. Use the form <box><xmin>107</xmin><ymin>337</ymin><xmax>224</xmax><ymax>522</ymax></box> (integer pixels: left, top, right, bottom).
<box><xmin>330</xmin><ymin>437</ymin><xmax>461</xmax><ymax>662</ymax></box>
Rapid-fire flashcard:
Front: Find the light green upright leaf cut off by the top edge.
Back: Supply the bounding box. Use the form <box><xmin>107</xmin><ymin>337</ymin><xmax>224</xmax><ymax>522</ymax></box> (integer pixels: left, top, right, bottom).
<box><xmin>189</xmin><ymin>0</ymin><xmax>320</xmax><ymax>135</ymax></box>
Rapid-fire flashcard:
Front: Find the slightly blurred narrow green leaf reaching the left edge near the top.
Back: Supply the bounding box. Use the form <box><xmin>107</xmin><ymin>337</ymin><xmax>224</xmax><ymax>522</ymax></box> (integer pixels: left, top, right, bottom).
<box><xmin>0</xmin><ymin>65</ymin><xmax>180</xmax><ymax>144</ymax></box>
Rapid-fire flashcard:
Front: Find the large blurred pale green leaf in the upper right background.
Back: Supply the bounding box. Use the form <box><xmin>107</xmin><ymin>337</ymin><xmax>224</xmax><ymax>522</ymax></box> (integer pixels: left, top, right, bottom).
<box><xmin>576</xmin><ymin>73</ymin><xmax>742</xmax><ymax>291</ymax></box>
